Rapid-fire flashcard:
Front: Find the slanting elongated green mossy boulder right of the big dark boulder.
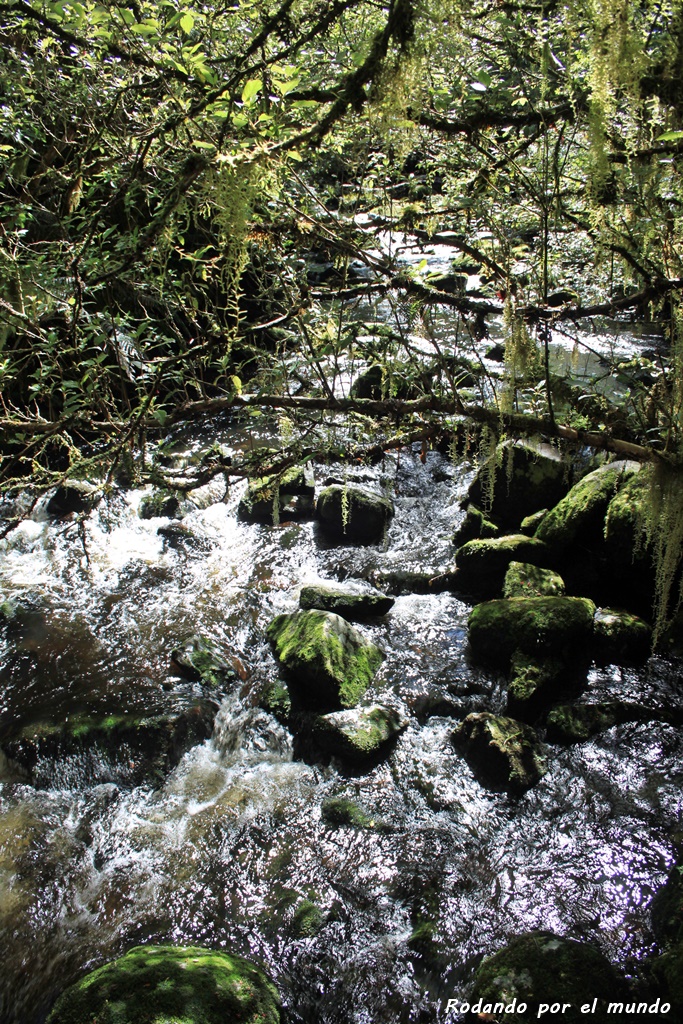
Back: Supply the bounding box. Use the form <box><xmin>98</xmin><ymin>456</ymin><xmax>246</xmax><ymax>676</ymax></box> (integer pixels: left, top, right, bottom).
<box><xmin>536</xmin><ymin>461</ymin><xmax>640</xmax><ymax>551</ymax></box>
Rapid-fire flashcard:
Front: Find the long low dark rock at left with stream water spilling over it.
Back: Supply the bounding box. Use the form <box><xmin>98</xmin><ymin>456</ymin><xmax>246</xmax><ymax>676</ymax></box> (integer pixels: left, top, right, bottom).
<box><xmin>2</xmin><ymin>700</ymin><xmax>217</xmax><ymax>785</ymax></box>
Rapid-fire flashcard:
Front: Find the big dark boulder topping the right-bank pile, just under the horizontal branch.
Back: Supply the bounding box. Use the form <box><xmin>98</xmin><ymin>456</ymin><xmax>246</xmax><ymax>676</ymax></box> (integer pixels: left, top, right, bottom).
<box><xmin>467</xmin><ymin>441</ymin><xmax>569</xmax><ymax>526</ymax></box>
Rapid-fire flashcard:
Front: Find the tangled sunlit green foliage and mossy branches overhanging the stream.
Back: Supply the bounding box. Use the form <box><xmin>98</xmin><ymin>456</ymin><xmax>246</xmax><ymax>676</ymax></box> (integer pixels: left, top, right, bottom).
<box><xmin>0</xmin><ymin>0</ymin><xmax>683</xmax><ymax>503</ymax></box>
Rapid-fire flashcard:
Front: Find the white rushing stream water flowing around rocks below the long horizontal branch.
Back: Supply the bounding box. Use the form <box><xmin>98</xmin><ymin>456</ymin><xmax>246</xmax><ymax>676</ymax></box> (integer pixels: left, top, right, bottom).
<box><xmin>0</xmin><ymin>436</ymin><xmax>683</xmax><ymax>1024</ymax></box>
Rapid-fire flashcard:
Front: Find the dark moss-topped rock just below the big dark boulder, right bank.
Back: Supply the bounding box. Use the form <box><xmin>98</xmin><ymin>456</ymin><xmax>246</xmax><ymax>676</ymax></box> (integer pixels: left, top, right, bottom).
<box><xmin>456</xmin><ymin>534</ymin><xmax>550</xmax><ymax>596</ymax></box>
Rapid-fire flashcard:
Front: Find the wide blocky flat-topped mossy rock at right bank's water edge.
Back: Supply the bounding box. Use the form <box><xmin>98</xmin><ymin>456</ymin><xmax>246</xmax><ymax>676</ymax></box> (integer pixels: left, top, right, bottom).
<box><xmin>468</xmin><ymin>597</ymin><xmax>595</xmax><ymax>665</ymax></box>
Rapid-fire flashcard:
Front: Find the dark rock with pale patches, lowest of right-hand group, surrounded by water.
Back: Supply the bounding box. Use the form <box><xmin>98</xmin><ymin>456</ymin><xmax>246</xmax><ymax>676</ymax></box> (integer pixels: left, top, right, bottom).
<box><xmin>453</xmin><ymin>712</ymin><xmax>546</xmax><ymax>793</ymax></box>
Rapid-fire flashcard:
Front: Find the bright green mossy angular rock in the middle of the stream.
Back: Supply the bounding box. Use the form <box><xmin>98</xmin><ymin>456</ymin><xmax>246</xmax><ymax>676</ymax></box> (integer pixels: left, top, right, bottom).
<box><xmin>267</xmin><ymin>610</ymin><xmax>383</xmax><ymax>710</ymax></box>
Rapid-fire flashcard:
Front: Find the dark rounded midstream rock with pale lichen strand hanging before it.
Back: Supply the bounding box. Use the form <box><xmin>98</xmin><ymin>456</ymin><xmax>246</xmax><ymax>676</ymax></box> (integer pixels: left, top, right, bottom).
<box><xmin>316</xmin><ymin>484</ymin><xmax>394</xmax><ymax>544</ymax></box>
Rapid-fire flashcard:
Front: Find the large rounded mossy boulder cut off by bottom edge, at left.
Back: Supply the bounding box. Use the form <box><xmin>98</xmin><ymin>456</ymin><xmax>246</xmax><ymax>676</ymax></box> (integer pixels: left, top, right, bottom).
<box><xmin>47</xmin><ymin>946</ymin><xmax>280</xmax><ymax>1024</ymax></box>
